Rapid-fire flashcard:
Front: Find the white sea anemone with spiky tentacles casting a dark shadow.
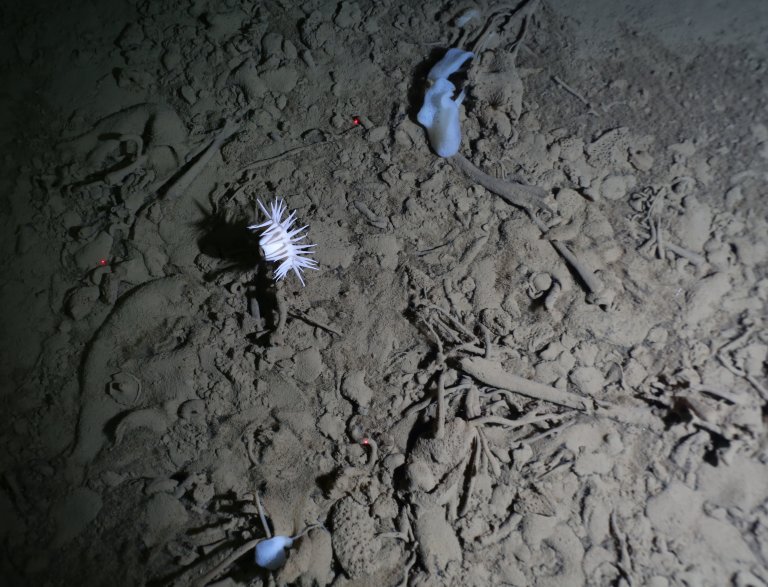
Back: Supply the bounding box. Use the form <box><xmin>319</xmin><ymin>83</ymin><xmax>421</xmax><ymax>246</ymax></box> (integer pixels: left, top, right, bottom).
<box><xmin>248</xmin><ymin>199</ymin><xmax>317</xmax><ymax>285</ymax></box>
